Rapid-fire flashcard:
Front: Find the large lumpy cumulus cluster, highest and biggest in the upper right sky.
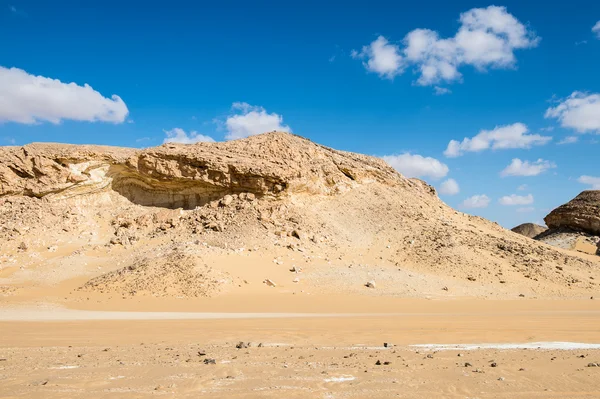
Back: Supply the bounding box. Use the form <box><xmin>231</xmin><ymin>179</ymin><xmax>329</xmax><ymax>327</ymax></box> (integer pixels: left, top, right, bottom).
<box><xmin>353</xmin><ymin>6</ymin><xmax>540</xmax><ymax>86</ymax></box>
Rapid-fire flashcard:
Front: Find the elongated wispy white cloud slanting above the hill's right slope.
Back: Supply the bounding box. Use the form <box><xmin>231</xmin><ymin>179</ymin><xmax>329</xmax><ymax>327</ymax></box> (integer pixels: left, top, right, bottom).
<box><xmin>444</xmin><ymin>123</ymin><xmax>552</xmax><ymax>158</ymax></box>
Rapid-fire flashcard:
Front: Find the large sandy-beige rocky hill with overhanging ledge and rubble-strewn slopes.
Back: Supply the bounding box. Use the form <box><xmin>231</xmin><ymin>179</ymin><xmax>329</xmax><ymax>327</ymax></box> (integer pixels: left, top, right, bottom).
<box><xmin>0</xmin><ymin>133</ymin><xmax>600</xmax><ymax>303</ymax></box>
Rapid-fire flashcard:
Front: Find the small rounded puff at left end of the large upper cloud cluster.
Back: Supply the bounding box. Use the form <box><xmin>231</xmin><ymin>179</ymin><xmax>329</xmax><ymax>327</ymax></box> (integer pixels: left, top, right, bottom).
<box><xmin>352</xmin><ymin>36</ymin><xmax>404</xmax><ymax>79</ymax></box>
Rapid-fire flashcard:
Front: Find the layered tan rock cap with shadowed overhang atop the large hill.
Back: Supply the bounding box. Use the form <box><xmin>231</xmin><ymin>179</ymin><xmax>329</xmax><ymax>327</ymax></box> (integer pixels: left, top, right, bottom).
<box><xmin>0</xmin><ymin>132</ymin><xmax>410</xmax><ymax>209</ymax></box>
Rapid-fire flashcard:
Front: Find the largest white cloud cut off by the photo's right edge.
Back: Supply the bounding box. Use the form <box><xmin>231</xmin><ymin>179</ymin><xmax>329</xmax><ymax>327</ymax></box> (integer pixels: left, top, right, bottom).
<box><xmin>545</xmin><ymin>91</ymin><xmax>600</xmax><ymax>133</ymax></box>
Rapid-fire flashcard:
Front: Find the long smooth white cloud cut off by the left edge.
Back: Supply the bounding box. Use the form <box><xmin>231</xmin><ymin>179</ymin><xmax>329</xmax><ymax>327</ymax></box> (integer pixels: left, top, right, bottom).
<box><xmin>0</xmin><ymin>66</ymin><xmax>129</xmax><ymax>125</ymax></box>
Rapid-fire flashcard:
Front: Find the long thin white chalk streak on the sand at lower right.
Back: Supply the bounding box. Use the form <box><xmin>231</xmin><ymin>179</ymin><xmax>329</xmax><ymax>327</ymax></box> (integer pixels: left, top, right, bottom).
<box><xmin>410</xmin><ymin>342</ymin><xmax>600</xmax><ymax>351</ymax></box>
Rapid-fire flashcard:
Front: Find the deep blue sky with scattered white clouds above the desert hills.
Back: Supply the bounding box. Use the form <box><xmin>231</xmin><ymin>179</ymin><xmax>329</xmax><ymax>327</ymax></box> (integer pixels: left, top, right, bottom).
<box><xmin>0</xmin><ymin>0</ymin><xmax>600</xmax><ymax>228</ymax></box>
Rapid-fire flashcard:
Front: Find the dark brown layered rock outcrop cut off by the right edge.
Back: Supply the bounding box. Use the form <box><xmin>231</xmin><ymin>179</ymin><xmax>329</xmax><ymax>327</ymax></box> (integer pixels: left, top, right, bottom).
<box><xmin>544</xmin><ymin>190</ymin><xmax>600</xmax><ymax>235</ymax></box>
